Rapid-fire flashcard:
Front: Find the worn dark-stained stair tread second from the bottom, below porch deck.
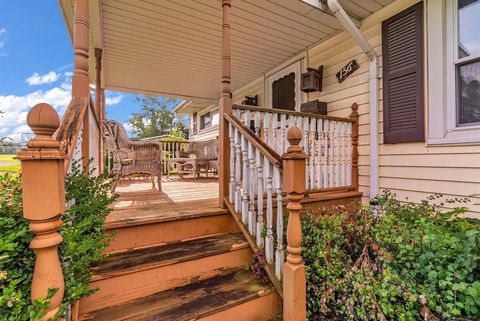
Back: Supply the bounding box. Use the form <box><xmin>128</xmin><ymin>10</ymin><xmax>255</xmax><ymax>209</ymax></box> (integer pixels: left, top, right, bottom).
<box><xmin>92</xmin><ymin>233</ymin><xmax>248</xmax><ymax>281</ymax></box>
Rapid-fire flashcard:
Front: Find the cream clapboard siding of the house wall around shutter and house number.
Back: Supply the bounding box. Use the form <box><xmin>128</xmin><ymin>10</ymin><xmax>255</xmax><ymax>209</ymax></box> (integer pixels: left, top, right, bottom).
<box><xmin>234</xmin><ymin>0</ymin><xmax>480</xmax><ymax>217</ymax></box>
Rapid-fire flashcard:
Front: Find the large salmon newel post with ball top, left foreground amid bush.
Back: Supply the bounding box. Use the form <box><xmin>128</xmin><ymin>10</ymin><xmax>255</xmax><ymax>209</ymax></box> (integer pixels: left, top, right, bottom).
<box><xmin>17</xmin><ymin>104</ymin><xmax>65</xmax><ymax>321</ymax></box>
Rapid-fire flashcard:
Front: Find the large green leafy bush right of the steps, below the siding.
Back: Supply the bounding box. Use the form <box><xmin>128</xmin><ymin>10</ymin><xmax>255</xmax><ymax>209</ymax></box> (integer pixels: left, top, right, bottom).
<box><xmin>302</xmin><ymin>193</ymin><xmax>480</xmax><ymax>320</ymax></box>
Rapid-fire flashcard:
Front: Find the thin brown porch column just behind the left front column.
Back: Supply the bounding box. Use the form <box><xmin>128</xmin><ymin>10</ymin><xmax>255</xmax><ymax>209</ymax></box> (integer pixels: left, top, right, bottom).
<box><xmin>95</xmin><ymin>48</ymin><xmax>105</xmax><ymax>174</ymax></box>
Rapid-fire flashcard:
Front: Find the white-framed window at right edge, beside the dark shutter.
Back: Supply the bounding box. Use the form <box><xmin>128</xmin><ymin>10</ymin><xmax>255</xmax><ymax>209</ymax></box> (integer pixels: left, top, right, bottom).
<box><xmin>426</xmin><ymin>0</ymin><xmax>480</xmax><ymax>144</ymax></box>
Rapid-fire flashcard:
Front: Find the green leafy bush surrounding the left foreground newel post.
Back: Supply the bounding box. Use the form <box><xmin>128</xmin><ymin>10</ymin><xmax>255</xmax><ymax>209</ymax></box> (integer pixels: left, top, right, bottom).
<box><xmin>0</xmin><ymin>164</ymin><xmax>115</xmax><ymax>321</ymax></box>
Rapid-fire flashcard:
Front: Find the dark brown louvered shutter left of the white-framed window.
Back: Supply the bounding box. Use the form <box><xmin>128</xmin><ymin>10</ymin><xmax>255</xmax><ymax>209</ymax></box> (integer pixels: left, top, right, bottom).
<box><xmin>382</xmin><ymin>2</ymin><xmax>425</xmax><ymax>144</ymax></box>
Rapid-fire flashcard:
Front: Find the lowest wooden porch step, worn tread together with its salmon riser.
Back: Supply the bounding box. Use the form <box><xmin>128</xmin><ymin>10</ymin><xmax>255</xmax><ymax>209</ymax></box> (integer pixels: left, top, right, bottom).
<box><xmin>79</xmin><ymin>268</ymin><xmax>281</xmax><ymax>321</ymax></box>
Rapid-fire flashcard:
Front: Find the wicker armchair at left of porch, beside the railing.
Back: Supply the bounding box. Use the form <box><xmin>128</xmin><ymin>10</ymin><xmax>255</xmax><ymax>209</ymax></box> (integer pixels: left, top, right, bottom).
<box><xmin>103</xmin><ymin>120</ymin><xmax>162</xmax><ymax>192</ymax></box>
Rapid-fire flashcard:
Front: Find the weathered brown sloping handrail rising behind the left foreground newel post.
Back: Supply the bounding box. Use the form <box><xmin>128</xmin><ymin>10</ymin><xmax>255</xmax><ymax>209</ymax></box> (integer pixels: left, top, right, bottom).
<box><xmin>54</xmin><ymin>97</ymin><xmax>88</xmax><ymax>173</ymax></box>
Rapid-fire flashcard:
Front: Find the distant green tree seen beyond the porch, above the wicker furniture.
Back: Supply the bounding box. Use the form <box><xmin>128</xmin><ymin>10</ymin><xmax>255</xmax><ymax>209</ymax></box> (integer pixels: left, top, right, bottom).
<box><xmin>128</xmin><ymin>96</ymin><xmax>188</xmax><ymax>138</ymax></box>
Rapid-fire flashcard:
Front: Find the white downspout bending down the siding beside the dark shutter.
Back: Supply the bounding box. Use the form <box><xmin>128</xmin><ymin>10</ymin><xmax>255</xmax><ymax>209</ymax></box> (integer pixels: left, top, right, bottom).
<box><xmin>328</xmin><ymin>0</ymin><xmax>379</xmax><ymax>200</ymax></box>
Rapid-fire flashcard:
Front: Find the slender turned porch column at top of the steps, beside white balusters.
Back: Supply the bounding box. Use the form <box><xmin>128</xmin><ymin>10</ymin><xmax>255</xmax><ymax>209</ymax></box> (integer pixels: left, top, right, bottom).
<box><xmin>218</xmin><ymin>0</ymin><xmax>232</xmax><ymax>207</ymax></box>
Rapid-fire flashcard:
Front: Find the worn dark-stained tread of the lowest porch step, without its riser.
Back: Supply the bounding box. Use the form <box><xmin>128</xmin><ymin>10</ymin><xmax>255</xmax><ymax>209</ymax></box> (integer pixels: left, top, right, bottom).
<box><xmin>84</xmin><ymin>269</ymin><xmax>275</xmax><ymax>321</ymax></box>
